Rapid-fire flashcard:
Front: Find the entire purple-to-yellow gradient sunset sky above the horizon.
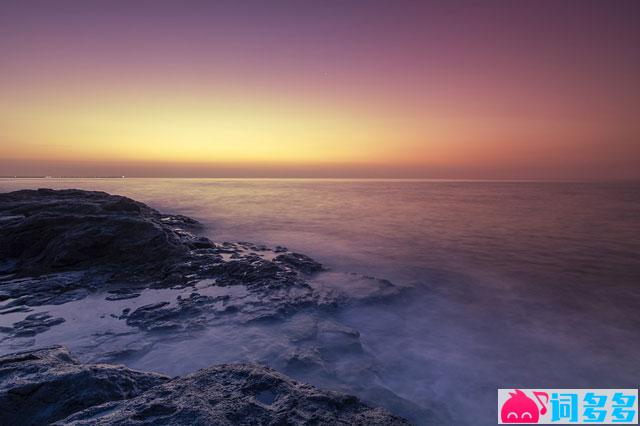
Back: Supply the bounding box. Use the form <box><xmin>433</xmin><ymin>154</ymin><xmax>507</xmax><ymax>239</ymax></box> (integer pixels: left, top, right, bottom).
<box><xmin>0</xmin><ymin>0</ymin><xmax>640</xmax><ymax>179</ymax></box>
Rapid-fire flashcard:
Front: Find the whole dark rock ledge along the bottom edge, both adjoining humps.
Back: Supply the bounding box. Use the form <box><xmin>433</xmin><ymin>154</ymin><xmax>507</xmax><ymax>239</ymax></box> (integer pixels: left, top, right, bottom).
<box><xmin>0</xmin><ymin>346</ymin><xmax>408</xmax><ymax>425</ymax></box>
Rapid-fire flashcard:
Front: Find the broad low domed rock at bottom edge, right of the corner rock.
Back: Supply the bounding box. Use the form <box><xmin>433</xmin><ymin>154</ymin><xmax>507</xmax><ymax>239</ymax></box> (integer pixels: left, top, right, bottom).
<box><xmin>58</xmin><ymin>364</ymin><xmax>408</xmax><ymax>425</ymax></box>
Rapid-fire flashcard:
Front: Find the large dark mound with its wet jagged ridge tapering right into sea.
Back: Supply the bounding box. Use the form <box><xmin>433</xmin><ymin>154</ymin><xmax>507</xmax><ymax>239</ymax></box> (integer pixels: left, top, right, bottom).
<box><xmin>0</xmin><ymin>189</ymin><xmax>338</xmax><ymax>309</ymax></box>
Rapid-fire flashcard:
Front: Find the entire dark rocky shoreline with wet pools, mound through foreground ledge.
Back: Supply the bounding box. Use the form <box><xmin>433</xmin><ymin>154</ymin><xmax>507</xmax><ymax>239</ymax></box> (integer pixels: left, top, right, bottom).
<box><xmin>0</xmin><ymin>189</ymin><xmax>447</xmax><ymax>425</ymax></box>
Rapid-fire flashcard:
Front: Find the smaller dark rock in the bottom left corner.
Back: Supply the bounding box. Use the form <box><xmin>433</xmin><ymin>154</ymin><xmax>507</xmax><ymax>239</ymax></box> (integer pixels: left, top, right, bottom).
<box><xmin>0</xmin><ymin>346</ymin><xmax>169</xmax><ymax>426</ymax></box>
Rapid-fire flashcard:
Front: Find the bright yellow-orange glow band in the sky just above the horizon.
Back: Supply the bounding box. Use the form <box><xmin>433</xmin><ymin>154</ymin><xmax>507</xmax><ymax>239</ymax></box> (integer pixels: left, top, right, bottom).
<box><xmin>0</xmin><ymin>86</ymin><xmax>632</xmax><ymax>175</ymax></box>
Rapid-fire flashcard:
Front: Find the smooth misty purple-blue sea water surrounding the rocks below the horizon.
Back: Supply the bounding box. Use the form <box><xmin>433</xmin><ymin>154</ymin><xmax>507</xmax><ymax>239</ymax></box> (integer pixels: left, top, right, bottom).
<box><xmin>0</xmin><ymin>179</ymin><xmax>640</xmax><ymax>424</ymax></box>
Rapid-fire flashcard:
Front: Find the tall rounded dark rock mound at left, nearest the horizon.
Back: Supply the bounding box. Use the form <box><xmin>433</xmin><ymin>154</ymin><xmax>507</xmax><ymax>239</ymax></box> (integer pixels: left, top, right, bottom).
<box><xmin>0</xmin><ymin>189</ymin><xmax>192</xmax><ymax>274</ymax></box>
